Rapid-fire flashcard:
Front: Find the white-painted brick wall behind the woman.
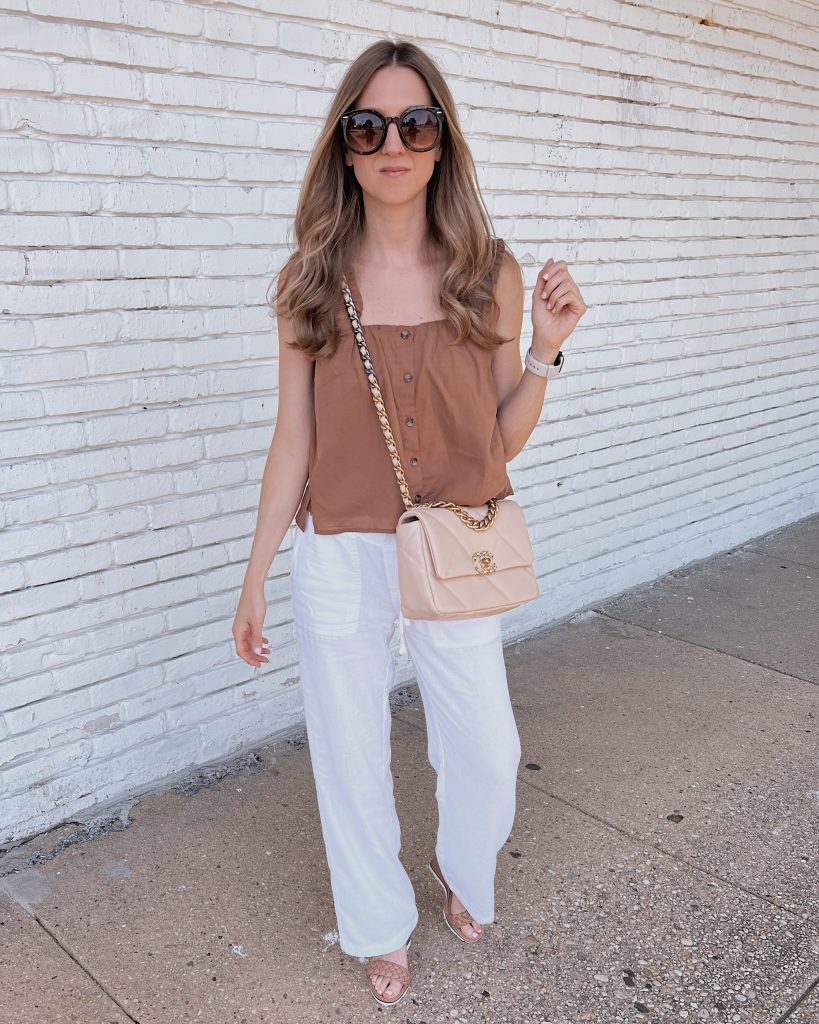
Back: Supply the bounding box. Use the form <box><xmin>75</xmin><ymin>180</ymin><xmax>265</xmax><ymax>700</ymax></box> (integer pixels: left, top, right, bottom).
<box><xmin>0</xmin><ymin>0</ymin><xmax>819</xmax><ymax>845</ymax></box>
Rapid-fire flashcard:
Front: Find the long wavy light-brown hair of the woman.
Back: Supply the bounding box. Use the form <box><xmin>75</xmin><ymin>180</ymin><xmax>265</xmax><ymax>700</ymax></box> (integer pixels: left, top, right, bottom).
<box><xmin>268</xmin><ymin>40</ymin><xmax>512</xmax><ymax>359</ymax></box>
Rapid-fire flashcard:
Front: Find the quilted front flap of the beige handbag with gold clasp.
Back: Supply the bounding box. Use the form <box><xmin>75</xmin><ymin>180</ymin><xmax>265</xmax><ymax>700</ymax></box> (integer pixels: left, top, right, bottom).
<box><xmin>398</xmin><ymin>499</ymin><xmax>533</xmax><ymax>580</ymax></box>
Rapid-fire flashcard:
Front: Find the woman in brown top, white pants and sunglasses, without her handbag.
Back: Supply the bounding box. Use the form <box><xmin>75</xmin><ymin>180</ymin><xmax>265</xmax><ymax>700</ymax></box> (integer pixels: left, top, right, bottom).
<box><xmin>233</xmin><ymin>41</ymin><xmax>586</xmax><ymax>1006</ymax></box>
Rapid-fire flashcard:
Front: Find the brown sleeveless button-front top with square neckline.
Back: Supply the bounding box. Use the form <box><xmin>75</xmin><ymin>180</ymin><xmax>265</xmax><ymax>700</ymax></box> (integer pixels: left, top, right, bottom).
<box><xmin>296</xmin><ymin>240</ymin><xmax>514</xmax><ymax>534</ymax></box>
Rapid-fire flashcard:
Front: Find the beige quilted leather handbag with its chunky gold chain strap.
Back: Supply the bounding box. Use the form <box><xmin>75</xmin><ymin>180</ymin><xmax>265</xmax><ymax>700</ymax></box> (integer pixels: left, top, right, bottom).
<box><xmin>342</xmin><ymin>281</ymin><xmax>540</xmax><ymax>618</ymax></box>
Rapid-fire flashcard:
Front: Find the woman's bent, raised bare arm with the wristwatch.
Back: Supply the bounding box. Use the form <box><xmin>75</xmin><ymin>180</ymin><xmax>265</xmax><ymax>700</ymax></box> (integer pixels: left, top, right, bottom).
<box><xmin>492</xmin><ymin>252</ymin><xmax>588</xmax><ymax>462</ymax></box>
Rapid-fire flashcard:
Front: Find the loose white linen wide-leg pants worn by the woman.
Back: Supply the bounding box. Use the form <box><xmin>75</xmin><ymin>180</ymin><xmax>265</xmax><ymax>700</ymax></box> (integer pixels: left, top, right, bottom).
<box><xmin>291</xmin><ymin>514</ymin><xmax>521</xmax><ymax>956</ymax></box>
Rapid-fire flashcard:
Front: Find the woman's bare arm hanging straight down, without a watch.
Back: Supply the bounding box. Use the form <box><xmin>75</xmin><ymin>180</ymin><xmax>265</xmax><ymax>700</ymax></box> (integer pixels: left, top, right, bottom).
<box><xmin>233</xmin><ymin>284</ymin><xmax>314</xmax><ymax>668</ymax></box>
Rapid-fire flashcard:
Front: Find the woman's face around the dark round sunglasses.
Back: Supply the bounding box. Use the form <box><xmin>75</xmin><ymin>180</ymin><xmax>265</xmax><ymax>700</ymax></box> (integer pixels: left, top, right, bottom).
<box><xmin>344</xmin><ymin>67</ymin><xmax>446</xmax><ymax>205</ymax></box>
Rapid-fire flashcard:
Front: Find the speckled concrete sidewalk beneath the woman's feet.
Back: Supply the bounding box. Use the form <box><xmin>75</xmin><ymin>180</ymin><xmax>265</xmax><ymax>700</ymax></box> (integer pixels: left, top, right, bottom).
<box><xmin>0</xmin><ymin>516</ymin><xmax>819</xmax><ymax>1024</ymax></box>
